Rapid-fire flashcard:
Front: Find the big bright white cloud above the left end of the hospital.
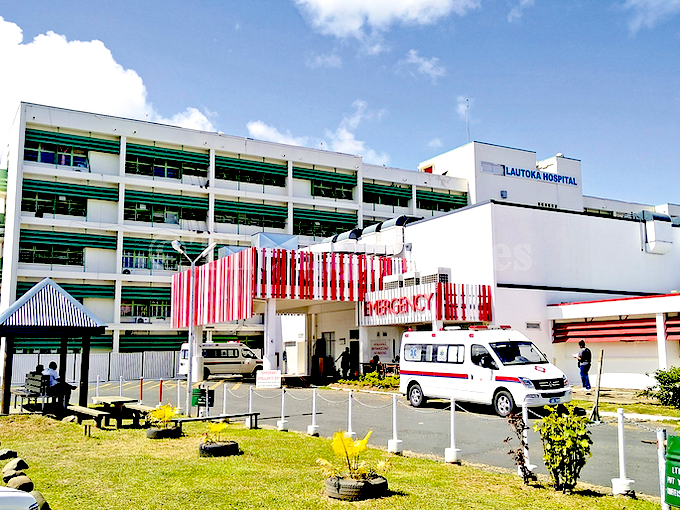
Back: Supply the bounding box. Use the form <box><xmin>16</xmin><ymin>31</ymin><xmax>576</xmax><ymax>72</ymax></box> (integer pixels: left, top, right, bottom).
<box><xmin>0</xmin><ymin>17</ymin><xmax>214</xmax><ymax>154</ymax></box>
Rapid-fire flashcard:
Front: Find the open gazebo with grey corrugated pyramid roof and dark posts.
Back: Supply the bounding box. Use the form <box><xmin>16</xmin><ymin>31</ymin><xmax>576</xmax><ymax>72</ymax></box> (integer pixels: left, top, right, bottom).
<box><xmin>0</xmin><ymin>278</ymin><xmax>105</xmax><ymax>414</ymax></box>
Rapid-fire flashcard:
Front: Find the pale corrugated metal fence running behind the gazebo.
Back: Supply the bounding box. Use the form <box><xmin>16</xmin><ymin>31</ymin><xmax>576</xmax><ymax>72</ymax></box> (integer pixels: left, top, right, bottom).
<box><xmin>12</xmin><ymin>351</ymin><xmax>179</xmax><ymax>384</ymax></box>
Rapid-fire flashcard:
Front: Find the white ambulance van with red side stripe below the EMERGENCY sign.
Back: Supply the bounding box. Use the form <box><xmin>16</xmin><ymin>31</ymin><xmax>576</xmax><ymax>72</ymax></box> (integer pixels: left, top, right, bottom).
<box><xmin>399</xmin><ymin>326</ymin><xmax>572</xmax><ymax>416</ymax></box>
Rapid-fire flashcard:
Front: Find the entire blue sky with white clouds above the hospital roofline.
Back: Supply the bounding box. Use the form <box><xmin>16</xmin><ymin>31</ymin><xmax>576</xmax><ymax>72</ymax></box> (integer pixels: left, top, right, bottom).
<box><xmin>0</xmin><ymin>0</ymin><xmax>680</xmax><ymax>204</ymax></box>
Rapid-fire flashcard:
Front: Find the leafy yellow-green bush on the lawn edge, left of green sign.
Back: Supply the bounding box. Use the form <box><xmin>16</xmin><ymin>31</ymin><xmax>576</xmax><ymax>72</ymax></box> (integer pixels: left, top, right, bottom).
<box><xmin>534</xmin><ymin>405</ymin><xmax>593</xmax><ymax>492</ymax></box>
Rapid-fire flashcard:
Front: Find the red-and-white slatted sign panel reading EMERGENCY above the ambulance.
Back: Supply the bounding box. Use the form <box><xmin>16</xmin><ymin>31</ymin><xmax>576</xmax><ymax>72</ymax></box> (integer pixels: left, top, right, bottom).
<box><xmin>358</xmin><ymin>283</ymin><xmax>491</xmax><ymax>326</ymax></box>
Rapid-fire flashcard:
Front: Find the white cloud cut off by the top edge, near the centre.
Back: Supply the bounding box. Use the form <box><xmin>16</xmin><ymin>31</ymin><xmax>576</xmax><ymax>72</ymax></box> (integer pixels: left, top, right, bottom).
<box><xmin>294</xmin><ymin>0</ymin><xmax>481</xmax><ymax>49</ymax></box>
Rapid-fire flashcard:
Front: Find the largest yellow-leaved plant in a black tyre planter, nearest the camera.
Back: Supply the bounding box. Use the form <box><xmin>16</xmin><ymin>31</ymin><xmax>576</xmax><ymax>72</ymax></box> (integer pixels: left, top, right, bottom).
<box><xmin>316</xmin><ymin>430</ymin><xmax>390</xmax><ymax>501</ymax></box>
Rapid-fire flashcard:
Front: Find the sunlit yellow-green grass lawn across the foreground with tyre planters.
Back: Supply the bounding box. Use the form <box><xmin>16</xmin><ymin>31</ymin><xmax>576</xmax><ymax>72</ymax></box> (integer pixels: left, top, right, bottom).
<box><xmin>0</xmin><ymin>416</ymin><xmax>658</xmax><ymax>510</ymax></box>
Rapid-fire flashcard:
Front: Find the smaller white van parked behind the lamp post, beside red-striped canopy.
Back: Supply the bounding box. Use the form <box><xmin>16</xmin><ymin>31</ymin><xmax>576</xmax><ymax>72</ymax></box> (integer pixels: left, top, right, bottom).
<box><xmin>178</xmin><ymin>342</ymin><xmax>262</xmax><ymax>379</ymax></box>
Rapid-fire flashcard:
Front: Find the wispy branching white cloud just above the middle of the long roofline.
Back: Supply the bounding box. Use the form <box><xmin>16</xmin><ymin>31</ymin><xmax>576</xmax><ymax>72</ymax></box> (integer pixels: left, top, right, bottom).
<box><xmin>246</xmin><ymin>99</ymin><xmax>390</xmax><ymax>165</ymax></box>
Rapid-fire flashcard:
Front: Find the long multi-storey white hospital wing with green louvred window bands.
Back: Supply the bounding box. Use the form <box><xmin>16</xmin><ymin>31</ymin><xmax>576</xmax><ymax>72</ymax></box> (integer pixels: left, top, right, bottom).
<box><xmin>0</xmin><ymin>103</ymin><xmax>468</xmax><ymax>358</ymax></box>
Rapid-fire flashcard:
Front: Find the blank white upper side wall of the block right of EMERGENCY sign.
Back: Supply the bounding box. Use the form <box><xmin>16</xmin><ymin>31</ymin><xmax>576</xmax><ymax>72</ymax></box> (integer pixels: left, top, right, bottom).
<box><xmin>493</xmin><ymin>204</ymin><xmax>680</xmax><ymax>292</ymax></box>
